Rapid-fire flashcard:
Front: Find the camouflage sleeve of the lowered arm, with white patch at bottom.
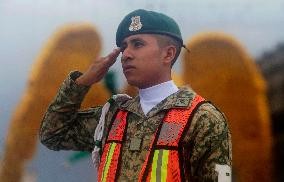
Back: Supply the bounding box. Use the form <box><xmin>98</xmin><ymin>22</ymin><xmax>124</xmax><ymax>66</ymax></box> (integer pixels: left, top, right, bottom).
<box><xmin>186</xmin><ymin>103</ymin><xmax>232</xmax><ymax>182</ymax></box>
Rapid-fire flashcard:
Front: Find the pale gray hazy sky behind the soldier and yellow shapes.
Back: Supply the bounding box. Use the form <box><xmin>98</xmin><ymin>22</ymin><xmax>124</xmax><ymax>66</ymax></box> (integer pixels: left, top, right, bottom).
<box><xmin>0</xmin><ymin>0</ymin><xmax>284</xmax><ymax>181</ymax></box>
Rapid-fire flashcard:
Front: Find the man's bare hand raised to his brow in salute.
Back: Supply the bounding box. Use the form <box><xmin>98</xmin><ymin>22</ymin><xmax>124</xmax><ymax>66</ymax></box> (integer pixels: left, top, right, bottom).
<box><xmin>75</xmin><ymin>48</ymin><xmax>120</xmax><ymax>86</ymax></box>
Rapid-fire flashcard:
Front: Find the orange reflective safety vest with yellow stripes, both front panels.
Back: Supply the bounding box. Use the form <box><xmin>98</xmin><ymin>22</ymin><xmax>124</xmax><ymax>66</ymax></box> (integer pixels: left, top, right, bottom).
<box><xmin>98</xmin><ymin>95</ymin><xmax>204</xmax><ymax>182</ymax></box>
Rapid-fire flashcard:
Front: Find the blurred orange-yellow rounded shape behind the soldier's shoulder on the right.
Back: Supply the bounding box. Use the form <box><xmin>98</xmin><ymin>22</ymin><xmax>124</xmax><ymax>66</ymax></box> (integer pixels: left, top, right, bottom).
<box><xmin>183</xmin><ymin>33</ymin><xmax>272</xmax><ymax>182</ymax></box>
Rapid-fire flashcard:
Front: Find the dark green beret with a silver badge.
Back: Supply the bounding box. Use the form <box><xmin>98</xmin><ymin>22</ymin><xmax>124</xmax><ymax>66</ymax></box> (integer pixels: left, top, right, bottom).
<box><xmin>116</xmin><ymin>9</ymin><xmax>183</xmax><ymax>47</ymax></box>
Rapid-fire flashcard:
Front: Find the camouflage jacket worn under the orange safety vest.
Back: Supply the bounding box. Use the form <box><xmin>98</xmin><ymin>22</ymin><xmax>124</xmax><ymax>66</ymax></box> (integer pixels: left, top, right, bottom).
<box><xmin>40</xmin><ymin>72</ymin><xmax>232</xmax><ymax>181</ymax></box>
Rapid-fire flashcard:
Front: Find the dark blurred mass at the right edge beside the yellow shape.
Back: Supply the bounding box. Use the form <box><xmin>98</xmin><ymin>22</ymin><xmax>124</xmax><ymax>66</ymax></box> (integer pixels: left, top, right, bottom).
<box><xmin>257</xmin><ymin>43</ymin><xmax>284</xmax><ymax>182</ymax></box>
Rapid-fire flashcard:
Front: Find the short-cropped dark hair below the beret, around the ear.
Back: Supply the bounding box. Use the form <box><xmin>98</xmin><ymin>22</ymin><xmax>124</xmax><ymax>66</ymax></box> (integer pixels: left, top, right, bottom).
<box><xmin>153</xmin><ymin>34</ymin><xmax>182</xmax><ymax>66</ymax></box>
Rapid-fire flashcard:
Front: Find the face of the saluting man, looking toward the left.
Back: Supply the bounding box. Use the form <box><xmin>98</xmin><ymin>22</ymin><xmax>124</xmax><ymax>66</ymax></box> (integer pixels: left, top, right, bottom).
<box><xmin>121</xmin><ymin>34</ymin><xmax>167</xmax><ymax>88</ymax></box>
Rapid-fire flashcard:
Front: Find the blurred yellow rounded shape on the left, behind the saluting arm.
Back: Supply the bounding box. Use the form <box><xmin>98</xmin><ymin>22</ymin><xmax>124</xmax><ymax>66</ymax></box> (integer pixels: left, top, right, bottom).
<box><xmin>0</xmin><ymin>23</ymin><xmax>110</xmax><ymax>182</ymax></box>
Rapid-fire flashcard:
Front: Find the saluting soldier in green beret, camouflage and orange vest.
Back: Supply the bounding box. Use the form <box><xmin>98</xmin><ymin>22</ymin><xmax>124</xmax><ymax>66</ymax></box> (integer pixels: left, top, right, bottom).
<box><xmin>40</xmin><ymin>9</ymin><xmax>232</xmax><ymax>181</ymax></box>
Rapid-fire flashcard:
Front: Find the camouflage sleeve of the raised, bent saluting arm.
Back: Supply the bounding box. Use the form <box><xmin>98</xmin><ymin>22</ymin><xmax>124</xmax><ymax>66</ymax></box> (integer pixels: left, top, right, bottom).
<box><xmin>39</xmin><ymin>71</ymin><xmax>101</xmax><ymax>151</ymax></box>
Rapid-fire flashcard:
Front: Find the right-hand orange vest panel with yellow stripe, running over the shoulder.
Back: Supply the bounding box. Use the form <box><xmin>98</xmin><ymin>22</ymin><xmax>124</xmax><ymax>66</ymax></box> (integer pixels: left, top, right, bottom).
<box><xmin>139</xmin><ymin>95</ymin><xmax>204</xmax><ymax>182</ymax></box>
